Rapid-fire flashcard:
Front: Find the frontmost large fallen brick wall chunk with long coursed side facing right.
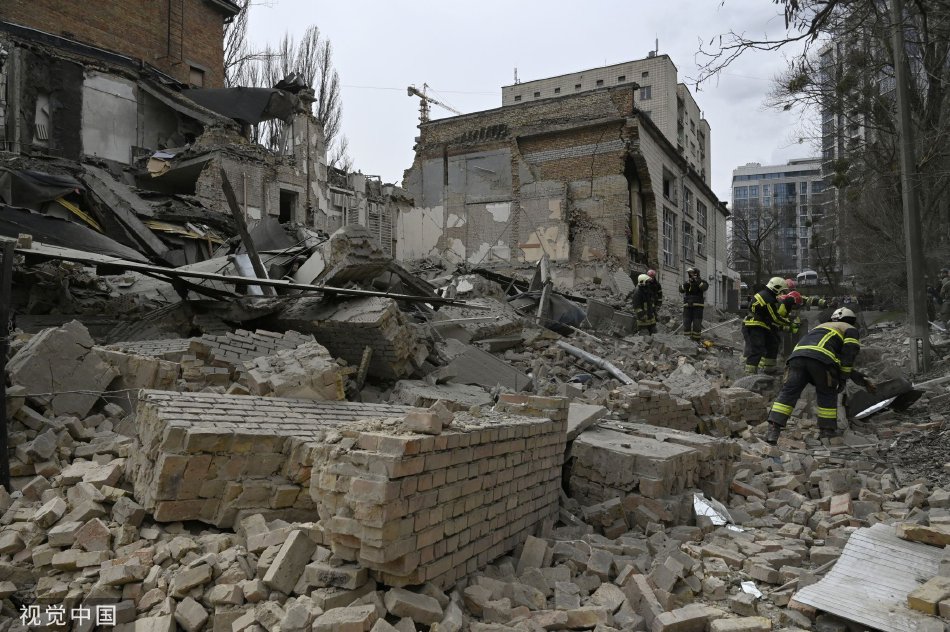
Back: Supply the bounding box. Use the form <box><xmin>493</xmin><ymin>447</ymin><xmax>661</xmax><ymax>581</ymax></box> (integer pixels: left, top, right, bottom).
<box><xmin>311</xmin><ymin>398</ymin><xmax>566</xmax><ymax>587</ymax></box>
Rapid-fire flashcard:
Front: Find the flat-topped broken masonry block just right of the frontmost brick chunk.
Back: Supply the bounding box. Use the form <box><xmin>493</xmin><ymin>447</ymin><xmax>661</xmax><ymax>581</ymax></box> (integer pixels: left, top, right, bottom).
<box><xmin>569</xmin><ymin>422</ymin><xmax>739</xmax><ymax>524</ymax></box>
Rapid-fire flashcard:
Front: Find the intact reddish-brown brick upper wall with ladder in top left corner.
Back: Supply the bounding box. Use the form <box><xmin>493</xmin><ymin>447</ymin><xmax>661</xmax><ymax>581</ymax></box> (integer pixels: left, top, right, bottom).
<box><xmin>0</xmin><ymin>0</ymin><xmax>231</xmax><ymax>88</ymax></box>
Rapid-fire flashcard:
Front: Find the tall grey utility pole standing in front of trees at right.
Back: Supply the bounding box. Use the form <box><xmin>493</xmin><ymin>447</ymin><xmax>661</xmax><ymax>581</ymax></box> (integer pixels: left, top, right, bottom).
<box><xmin>891</xmin><ymin>0</ymin><xmax>930</xmax><ymax>375</ymax></box>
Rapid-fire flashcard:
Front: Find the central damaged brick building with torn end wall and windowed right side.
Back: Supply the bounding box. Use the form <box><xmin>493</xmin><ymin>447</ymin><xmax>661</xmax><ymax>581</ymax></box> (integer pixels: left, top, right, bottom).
<box><xmin>397</xmin><ymin>56</ymin><xmax>736</xmax><ymax>306</ymax></box>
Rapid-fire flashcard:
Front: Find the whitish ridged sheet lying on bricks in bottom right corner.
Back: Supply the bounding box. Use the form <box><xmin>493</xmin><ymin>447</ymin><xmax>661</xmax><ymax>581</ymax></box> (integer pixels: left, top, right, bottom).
<box><xmin>794</xmin><ymin>524</ymin><xmax>943</xmax><ymax>632</ymax></box>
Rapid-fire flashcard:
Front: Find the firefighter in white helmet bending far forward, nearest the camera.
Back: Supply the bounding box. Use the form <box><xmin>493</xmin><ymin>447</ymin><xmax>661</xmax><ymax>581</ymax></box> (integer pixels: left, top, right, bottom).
<box><xmin>765</xmin><ymin>307</ymin><xmax>875</xmax><ymax>445</ymax></box>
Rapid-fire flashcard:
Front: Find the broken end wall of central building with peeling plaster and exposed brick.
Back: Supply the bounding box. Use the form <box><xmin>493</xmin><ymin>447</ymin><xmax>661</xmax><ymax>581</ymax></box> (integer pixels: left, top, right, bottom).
<box><xmin>397</xmin><ymin>88</ymin><xmax>656</xmax><ymax>270</ymax></box>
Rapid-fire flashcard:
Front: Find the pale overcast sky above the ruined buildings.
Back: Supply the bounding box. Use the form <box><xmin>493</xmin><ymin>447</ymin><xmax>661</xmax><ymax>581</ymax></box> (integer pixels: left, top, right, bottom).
<box><xmin>249</xmin><ymin>0</ymin><xmax>816</xmax><ymax>202</ymax></box>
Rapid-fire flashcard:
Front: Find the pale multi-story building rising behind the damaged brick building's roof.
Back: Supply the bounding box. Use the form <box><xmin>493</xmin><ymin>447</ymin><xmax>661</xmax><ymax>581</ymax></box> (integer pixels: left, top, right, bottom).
<box><xmin>501</xmin><ymin>53</ymin><xmax>711</xmax><ymax>184</ymax></box>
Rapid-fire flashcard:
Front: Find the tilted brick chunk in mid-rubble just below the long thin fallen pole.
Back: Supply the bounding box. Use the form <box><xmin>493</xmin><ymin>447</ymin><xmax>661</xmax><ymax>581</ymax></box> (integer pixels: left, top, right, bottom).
<box><xmin>279</xmin><ymin>297</ymin><xmax>429</xmax><ymax>380</ymax></box>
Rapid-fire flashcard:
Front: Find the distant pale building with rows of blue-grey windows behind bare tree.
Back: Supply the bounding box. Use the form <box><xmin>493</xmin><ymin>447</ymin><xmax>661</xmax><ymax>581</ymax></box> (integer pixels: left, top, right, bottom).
<box><xmin>731</xmin><ymin>158</ymin><xmax>825</xmax><ymax>283</ymax></box>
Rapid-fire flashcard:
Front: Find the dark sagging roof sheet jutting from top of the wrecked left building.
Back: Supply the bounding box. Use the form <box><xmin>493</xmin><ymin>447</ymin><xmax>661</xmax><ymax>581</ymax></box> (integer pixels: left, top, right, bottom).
<box><xmin>182</xmin><ymin>87</ymin><xmax>300</xmax><ymax>125</ymax></box>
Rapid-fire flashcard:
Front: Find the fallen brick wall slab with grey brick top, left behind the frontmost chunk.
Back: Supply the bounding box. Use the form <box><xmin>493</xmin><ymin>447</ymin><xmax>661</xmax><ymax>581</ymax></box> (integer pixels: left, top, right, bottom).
<box><xmin>129</xmin><ymin>391</ymin><xmax>409</xmax><ymax>527</ymax></box>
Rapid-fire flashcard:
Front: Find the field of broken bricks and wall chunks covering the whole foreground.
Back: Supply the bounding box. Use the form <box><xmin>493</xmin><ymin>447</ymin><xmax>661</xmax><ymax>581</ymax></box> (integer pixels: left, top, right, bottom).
<box><xmin>0</xmin><ymin>235</ymin><xmax>950</xmax><ymax>632</ymax></box>
